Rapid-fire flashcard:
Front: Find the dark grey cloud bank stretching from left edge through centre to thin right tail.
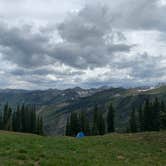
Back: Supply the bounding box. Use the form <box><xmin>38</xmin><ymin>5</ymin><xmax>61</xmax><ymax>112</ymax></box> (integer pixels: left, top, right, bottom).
<box><xmin>0</xmin><ymin>6</ymin><xmax>132</xmax><ymax>69</ymax></box>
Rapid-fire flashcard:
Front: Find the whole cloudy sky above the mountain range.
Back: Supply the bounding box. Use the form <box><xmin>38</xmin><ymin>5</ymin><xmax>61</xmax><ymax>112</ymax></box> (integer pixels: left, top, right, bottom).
<box><xmin>0</xmin><ymin>0</ymin><xmax>166</xmax><ymax>89</ymax></box>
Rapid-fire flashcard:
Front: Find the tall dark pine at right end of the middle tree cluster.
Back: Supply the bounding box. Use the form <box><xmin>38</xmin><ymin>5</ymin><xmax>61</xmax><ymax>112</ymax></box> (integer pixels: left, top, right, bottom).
<box><xmin>107</xmin><ymin>104</ymin><xmax>115</xmax><ymax>133</ymax></box>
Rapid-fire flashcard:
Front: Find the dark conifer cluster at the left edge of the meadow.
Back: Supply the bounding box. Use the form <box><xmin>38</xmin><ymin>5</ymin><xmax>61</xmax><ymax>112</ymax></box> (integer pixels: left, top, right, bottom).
<box><xmin>0</xmin><ymin>103</ymin><xmax>43</xmax><ymax>135</ymax></box>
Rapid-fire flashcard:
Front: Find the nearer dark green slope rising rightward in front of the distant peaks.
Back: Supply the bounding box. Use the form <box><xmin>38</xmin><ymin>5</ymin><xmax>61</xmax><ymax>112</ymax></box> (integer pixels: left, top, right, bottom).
<box><xmin>41</xmin><ymin>86</ymin><xmax>166</xmax><ymax>135</ymax></box>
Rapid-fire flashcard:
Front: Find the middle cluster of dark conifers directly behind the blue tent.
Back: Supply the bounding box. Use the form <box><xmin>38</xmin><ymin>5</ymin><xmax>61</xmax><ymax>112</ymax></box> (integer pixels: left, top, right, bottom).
<box><xmin>65</xmin><ymin>104</ymin><xmax>115</xmax><ymax>136</ymax></box>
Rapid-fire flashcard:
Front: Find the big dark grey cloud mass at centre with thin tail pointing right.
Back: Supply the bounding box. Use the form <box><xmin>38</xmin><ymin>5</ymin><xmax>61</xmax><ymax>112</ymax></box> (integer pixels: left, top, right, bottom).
<box><xmin>52</xmin><ymin>5</ymin><xmax>132</xmax><ymax>68</ymax></box>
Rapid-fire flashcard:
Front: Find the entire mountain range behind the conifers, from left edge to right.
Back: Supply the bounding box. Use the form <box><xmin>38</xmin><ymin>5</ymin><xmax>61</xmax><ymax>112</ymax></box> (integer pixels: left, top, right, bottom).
<box><xmin>0</xmin><ymin>84</ymin><xmax>166</xmax><ymax>135</ymax></box>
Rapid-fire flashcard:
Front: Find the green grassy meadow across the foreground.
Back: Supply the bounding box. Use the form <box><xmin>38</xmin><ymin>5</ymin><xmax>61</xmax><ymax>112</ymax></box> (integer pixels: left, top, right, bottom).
<box><xmin>0</xmin><ymin>132</ymin><xmax>166</xmax><ymax>166</ymax></box>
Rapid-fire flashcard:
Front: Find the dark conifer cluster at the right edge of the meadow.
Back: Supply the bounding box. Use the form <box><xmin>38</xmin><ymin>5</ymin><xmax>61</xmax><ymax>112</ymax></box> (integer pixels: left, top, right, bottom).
<box><xmin>128</xmin><ymin>98</ymin><xmax>166</xmax><ymax>132</ymax></box>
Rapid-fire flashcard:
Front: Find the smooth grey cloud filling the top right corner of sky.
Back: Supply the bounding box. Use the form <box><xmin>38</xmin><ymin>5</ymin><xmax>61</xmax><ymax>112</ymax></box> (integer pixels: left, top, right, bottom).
<box><xmin>112</xmin><ymin>0</ymin><xmax>166</xmax><ymax>31</ymax></box>
